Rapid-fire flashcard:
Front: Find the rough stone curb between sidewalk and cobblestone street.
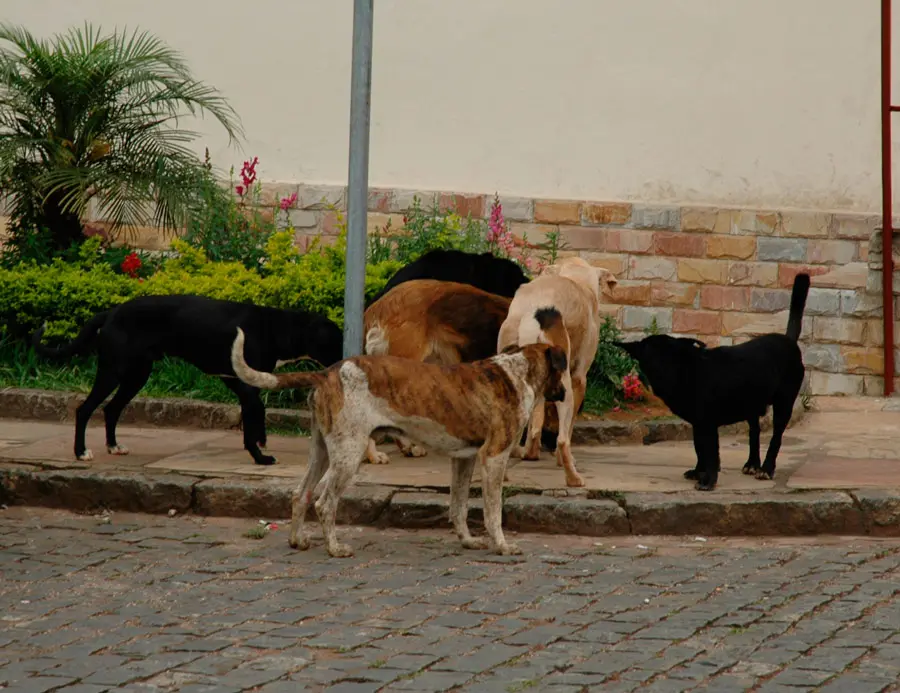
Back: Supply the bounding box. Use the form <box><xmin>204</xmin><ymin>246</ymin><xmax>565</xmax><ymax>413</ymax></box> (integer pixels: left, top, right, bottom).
<box><xmin>0</xmin><ymin>464</ymin><xmax>900</xmax><ymax>537</ymax></box>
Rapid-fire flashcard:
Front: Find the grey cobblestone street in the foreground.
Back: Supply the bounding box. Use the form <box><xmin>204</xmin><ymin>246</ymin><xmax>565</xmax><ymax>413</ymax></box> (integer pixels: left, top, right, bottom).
<box><xmin>0</xmin><ymin>508</ymin><xmax>900</xmax><ymax>693</ymax></box>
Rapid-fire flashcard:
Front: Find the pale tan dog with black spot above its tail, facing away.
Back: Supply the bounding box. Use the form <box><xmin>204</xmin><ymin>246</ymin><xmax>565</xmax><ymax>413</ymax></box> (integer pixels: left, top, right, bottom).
<box><xmin>497</xmin><ymin>257</ymin><xmax>618</xmax><ymax>486</ymax></box>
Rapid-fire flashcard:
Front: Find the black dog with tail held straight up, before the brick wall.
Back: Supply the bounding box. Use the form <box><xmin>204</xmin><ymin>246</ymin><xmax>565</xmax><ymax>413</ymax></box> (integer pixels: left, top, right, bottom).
<box><xmin>617</xmin><ymin>274</ymin><xmax>809</xmax><ymax>491</ymax></box>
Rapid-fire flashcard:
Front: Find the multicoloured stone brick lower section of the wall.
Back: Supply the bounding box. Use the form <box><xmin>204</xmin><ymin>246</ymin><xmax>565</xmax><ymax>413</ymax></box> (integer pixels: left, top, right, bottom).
<box><xmin>7</xmin><ymin>183</ymin><xmax>900</xmax><ymax>395</ymax></box>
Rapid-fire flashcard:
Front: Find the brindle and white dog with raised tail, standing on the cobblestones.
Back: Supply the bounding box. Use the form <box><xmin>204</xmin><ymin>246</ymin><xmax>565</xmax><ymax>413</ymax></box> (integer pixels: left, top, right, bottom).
<box><xmin>231</xmin><ymin>312</ymin><xmax>568</xmax><ymax>557</ymax></box>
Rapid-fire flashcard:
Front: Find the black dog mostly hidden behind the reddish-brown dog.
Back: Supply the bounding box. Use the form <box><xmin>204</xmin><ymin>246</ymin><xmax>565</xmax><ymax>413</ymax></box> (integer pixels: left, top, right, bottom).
<box><xmin>371</xmin><ymin>250</ymin><xmax>528</xmax><ymax>303</ymax></box>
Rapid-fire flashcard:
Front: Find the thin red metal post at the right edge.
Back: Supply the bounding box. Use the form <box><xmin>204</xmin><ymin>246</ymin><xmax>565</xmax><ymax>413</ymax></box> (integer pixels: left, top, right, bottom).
<box><xmin>881</xmin><ymin>0</ymin><xmax>900</xmax><ymax>397</ymax></box>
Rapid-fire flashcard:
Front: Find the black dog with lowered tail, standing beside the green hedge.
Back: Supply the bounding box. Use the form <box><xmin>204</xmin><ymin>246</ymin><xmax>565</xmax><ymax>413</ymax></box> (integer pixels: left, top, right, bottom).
<box><xmin>32</xmin><ymin>295</ymin><xmax>343</xmax><ymax>464</ymax></box>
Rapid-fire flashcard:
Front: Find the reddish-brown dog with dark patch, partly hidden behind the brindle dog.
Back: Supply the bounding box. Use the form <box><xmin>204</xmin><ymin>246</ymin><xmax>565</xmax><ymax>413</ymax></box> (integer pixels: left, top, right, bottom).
<box><xmin>365</xmin><ymin>279</ymin><xmax>510</xmax><ymax>464</ymax></box>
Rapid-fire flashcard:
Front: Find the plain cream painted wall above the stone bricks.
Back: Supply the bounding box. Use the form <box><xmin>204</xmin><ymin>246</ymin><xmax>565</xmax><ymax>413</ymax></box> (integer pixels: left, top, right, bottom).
<box><xmin>2</xmin><ymin>0</ymin><xmax>900</xmax><ymax>212</ymax></box>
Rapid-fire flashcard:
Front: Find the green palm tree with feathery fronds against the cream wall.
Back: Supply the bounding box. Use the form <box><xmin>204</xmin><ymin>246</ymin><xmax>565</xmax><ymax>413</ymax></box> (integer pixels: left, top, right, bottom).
<box><xmin>0</xmin><ymin>24</ymin><xmax>242</xmax><ymax>250</ymax></box>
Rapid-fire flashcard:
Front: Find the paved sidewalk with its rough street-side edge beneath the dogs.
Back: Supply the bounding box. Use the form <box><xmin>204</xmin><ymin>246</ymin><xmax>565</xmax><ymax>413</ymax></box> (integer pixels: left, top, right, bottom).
<box><xmin>0</xmin><ymin>398</ymin><xmax>900</xmax><ymax>534</ymax></box>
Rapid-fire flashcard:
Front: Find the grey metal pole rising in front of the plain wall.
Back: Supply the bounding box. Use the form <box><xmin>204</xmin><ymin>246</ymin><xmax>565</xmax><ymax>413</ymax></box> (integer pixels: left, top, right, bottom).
<box><xmin>344</xmin><ymin>0</ymin><xmax>374</xmax><ymax>358</ymax></box>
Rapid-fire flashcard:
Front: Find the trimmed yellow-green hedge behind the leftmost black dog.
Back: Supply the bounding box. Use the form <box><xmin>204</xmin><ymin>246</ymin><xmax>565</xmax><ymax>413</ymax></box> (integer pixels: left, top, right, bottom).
<box><xmin>0</xmin><ymin>233</ymin><xmax>400</xmax><ymax>338</ymax></box>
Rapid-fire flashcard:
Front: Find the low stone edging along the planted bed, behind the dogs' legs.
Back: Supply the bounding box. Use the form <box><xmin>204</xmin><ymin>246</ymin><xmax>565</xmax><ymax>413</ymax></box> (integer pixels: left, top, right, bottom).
<box><xmin>0</xmin><ymin>388</ymin><xmax>805</xmax><ymax>445</ymax></box>
